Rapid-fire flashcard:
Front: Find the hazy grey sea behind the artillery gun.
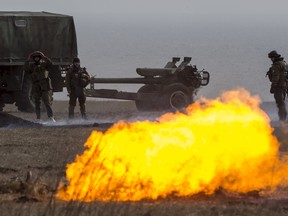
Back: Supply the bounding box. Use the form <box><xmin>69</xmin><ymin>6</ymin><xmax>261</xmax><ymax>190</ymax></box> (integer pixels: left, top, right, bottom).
<box><xmin>54</xmin><ymin>14</ymin><xmax>288</xmax><ymax>101</ymax></box>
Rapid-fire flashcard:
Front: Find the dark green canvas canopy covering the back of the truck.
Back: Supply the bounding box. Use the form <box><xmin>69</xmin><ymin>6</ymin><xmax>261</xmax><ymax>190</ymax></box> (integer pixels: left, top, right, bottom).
<box><xmin>0</xmin><ymin>11</ymin><xmax>77</xmax><ymax>65</ymax></box>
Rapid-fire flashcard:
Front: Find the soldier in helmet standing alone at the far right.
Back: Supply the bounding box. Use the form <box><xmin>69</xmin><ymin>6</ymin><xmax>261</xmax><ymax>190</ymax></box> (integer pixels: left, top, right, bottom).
<box><xmin>268</xmin><ymin>50</ymin><xmax>287</xmax><ymax>121</ymax></box>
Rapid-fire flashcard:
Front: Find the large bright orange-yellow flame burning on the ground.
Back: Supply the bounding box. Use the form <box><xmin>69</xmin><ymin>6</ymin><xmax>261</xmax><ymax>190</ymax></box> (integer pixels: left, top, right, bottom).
<box><xmin>57</xmin><ymin>89</ymin><xmax>288</xmax><ymax>202</ymax></box>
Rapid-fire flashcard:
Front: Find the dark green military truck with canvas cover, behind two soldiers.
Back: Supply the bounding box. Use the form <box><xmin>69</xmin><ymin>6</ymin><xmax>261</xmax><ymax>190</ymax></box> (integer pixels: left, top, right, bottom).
<box><xmin>0</xmin><ymin>11</ymin><xmax>78</xmax><ymax>111</ymax></box>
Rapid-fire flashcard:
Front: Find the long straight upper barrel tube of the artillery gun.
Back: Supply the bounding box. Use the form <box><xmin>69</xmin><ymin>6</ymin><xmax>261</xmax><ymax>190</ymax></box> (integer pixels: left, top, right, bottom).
<box><xmin>90</xmin><ymin>77</ymin><xmax>163</xmax><ymax>84</ymax></box>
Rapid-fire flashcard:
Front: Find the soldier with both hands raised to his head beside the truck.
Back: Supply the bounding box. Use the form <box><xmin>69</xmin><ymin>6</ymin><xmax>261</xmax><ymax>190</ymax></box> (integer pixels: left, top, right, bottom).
<box><xmin>24</xmin><ymin>51</ymin><xmax>55</xmax><ymax>122</ymax></box>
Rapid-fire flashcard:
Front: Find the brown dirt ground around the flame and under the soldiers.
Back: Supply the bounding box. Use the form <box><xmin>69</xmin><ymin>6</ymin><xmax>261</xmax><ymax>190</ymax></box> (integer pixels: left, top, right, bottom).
<box><xmin>0</xmin><ymin>101</ymin><xmax>288</xmax><ymax>216</ymax></box>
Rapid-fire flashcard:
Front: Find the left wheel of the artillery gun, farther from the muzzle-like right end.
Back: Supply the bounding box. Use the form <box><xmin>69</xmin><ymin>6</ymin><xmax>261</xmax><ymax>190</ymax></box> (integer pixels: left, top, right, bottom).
<box><xmin>135</xmin><ymin>85</ymin><xmax>158</xmax><ymax>111</ymax></box>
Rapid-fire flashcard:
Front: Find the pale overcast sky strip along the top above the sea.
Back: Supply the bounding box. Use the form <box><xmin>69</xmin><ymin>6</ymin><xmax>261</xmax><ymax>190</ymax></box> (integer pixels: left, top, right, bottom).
<box><xmin>0</xmin><ymin>0</ymin><xmax>288</xmax><ymax>16</ymax></box>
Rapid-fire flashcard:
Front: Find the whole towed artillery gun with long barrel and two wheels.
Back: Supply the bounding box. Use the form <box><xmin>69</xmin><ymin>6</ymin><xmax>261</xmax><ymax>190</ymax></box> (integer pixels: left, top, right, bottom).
<box><xmin>86</xmin><ymin>57</ymin><xmax>210</xmax><ymax>111</ymax></box>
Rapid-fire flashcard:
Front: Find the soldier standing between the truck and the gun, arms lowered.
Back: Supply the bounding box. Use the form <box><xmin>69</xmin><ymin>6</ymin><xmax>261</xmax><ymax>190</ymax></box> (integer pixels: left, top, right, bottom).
<box><xmin>66</xmin><ymin>58</ymin><xmax>90</xmax><ymax>119</ymax></box>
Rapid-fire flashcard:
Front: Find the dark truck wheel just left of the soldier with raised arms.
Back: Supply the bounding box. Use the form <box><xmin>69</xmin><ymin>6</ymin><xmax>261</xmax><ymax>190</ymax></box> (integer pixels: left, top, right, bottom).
<box><xmin>14</xmin><ymin>76</ymin><xmax>34</xmax><ymax>112</ymax></box>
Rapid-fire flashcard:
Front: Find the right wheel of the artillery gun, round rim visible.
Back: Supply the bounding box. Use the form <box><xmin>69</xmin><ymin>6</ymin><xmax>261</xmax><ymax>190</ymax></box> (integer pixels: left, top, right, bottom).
<box><xmin>161</xmin><ymin>83</ymin><xmax>193</xmax><ymax>110</ymax></box>
